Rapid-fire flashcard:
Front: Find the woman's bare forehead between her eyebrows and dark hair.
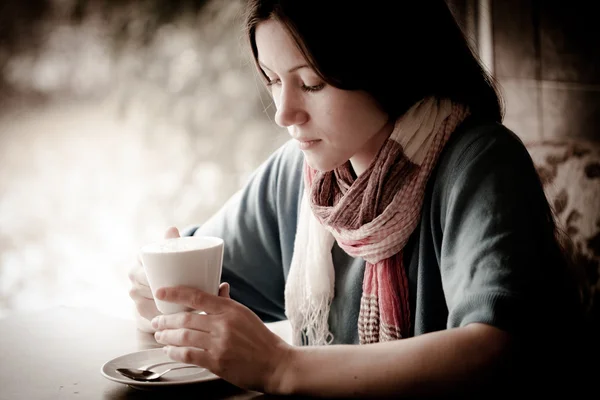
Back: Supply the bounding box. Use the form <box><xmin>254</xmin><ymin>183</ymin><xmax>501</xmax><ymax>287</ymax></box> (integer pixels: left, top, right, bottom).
<box><xmin>255</xmin><ymin>20</ymin><xmax>306</xmax><ymax>72</ymax></box>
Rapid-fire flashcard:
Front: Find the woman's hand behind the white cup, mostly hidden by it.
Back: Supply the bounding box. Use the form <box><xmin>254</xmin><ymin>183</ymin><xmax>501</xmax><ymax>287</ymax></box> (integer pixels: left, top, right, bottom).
<box><xmin>129</xmin><ymin>227</ymin><xmax>179</xmax><ymax>330</ymax></box>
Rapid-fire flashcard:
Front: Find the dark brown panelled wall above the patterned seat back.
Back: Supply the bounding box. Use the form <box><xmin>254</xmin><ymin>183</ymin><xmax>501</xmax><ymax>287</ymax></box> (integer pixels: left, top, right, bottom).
<box><xmin>492</xmin><ymin>0</ymin><xmax>600</xmax><ymax>141</ymax></box>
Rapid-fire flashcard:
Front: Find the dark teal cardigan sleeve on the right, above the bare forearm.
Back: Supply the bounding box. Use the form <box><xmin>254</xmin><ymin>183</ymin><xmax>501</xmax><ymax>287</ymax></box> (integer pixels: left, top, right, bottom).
<box><xmin>440</xmin><ymin>125</ymin><xmax>566</xmax><ymax>331</ymax></box>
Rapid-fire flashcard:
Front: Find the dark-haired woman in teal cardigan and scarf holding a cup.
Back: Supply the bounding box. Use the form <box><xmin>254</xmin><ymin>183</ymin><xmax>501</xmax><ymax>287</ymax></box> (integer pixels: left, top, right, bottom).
<box><xmin>130</xmin><ymin>0</ymin><xmax>578</xmax><ymax>397</ymax></box>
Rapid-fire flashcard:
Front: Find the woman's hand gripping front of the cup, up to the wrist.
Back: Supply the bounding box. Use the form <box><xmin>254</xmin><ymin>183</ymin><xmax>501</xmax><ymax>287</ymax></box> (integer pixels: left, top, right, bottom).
<box><xmin>152</xmin><ymin>283</ymin><xmax>292</xmax><ymax>393</ymax></box>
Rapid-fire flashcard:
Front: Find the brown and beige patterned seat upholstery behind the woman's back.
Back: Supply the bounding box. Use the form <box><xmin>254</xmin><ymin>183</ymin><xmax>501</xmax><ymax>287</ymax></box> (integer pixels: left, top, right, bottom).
<box><xmin>526</xmin><ymin>140</ymin><xmax>600</xmax><ymax>326</ymax></box>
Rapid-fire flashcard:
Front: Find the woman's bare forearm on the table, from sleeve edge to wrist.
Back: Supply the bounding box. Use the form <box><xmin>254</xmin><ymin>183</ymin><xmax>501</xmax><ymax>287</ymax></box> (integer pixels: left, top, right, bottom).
<box><xmin>275</xmin><ymin>323</ymin><xmax>510</xmax><ymax>397</ymax></box>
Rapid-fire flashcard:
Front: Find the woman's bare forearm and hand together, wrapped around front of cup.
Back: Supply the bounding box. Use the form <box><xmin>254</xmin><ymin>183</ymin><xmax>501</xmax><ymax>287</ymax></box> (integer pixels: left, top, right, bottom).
<box><xmin>152</xmin><ymin>287</ymin><xmax>509</xmax><ymax>398</ymax></box>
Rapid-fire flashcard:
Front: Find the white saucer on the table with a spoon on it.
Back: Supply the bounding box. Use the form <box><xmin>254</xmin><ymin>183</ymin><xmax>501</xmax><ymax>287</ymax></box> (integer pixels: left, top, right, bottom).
<box><xmin>100</xmin><ymin>349</ymin><xmax>220</xmax><ymax>389</ymax></box>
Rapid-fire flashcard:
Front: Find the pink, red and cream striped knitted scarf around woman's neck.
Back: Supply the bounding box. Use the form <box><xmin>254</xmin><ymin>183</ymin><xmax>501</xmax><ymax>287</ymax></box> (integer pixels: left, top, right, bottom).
<box><xmin>285</xmin><ymin>98</ymin><xmax>468</xmax><ymax>345</ymax></box>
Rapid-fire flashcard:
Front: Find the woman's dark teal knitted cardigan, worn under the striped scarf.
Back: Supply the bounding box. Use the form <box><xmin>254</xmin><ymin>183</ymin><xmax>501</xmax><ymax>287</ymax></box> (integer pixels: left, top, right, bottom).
<box><xmin>186</xmin><ymin>120</ymin><xmax>578</xmax><ymax>390</ymax></box>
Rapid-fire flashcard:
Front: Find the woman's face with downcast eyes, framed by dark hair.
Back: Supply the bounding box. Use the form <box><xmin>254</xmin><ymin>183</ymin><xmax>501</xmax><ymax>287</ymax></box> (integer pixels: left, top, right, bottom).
<box><xmin>255</xmin><ymin>20</ymin><xmax>393</xmax><ymax>175</ymax></box>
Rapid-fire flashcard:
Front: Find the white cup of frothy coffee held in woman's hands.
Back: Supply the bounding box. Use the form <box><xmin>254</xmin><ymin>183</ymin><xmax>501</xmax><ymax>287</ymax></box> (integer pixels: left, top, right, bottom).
<box><xmin>140</xmin><ymin>236</ymin><xmax>224</xmax><ymax>314</ymax></box>
